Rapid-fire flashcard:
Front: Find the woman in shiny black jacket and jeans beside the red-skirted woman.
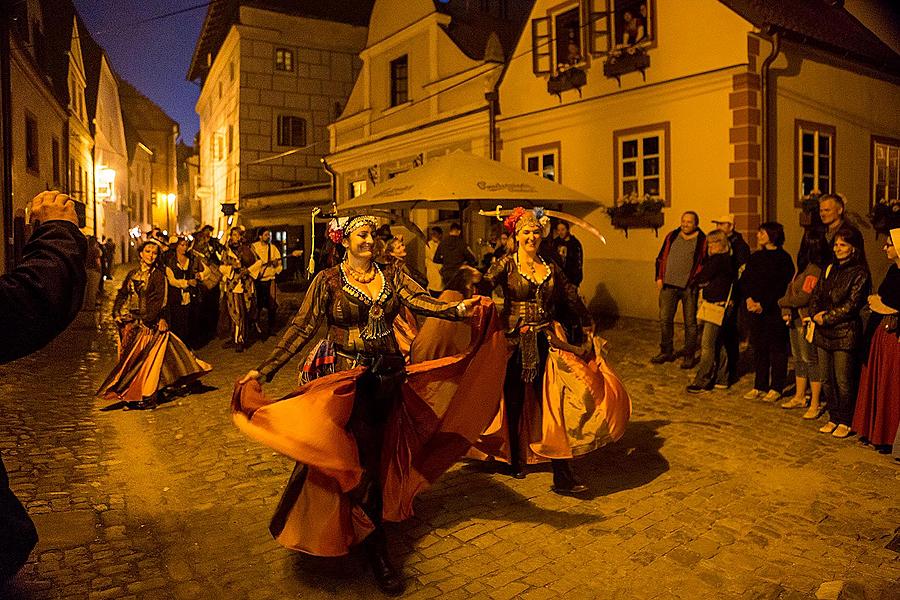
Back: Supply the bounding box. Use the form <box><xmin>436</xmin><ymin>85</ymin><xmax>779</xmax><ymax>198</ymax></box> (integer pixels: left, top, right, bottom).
<box><xmin>810</xmin><ymin>227</ymin><xmax>872</xmax><ymax>438</ymax></box>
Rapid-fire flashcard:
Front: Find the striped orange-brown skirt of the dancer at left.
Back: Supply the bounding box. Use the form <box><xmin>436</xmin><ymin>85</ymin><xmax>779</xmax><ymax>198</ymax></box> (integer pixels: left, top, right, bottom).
<box><xmin>97</xmin><ymin>323</ymin><xmax>212</xmax><ymax>402</ymax></box>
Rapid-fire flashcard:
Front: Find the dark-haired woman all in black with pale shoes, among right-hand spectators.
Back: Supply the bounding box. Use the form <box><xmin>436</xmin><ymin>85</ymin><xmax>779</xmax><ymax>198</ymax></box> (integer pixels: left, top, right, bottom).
<box><xmin>740</xmin><ymin>222</ymin><xmax>794</xmax><ymax>402</ymax></box>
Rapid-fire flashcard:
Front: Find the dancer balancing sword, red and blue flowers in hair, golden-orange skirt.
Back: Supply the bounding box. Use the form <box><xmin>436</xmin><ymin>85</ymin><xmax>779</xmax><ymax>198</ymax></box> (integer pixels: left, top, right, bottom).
<box><xmin>476</xmin><ymin>207</ymin><xmax>631</xmax><ymax>495</ymax></box>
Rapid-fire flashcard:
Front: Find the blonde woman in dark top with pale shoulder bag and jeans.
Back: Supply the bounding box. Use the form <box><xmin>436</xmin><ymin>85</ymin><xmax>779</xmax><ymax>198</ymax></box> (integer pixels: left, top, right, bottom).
<box><xmin>687</xmin><ymin>230</ymin><xmax>737</xmax><ymax>394</ymax></box>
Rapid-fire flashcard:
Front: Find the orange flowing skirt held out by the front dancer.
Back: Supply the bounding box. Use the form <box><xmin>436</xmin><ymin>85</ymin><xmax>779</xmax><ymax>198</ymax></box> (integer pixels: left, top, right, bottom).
<box><xmin>232</xmin><ymin>300</ymin><xmax>507</xmax><ymax>556</ymax></box>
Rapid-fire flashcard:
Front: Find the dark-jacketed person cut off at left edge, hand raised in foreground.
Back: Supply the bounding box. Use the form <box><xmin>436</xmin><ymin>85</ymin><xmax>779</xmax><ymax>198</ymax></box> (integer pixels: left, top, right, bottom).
<box><xmin>0</xmin><ymin>192</ymin><xmax>87</xmax><ymax>582</ymax></box>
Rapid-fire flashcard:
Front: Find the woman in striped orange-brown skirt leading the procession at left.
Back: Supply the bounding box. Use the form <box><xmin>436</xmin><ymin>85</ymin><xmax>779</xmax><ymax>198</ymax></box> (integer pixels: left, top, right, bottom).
<box><xmin>97</xmin><ymin>241</ymin><xmax>212</xmax><ymax>408</ymax></box>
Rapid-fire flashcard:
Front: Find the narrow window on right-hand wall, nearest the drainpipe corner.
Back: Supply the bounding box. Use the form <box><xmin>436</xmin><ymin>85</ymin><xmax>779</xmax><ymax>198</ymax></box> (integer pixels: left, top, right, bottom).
<box><xmin>795</xmin><ymin>120</ymin><xmax>835</xmax><ymax>201</ymax></box>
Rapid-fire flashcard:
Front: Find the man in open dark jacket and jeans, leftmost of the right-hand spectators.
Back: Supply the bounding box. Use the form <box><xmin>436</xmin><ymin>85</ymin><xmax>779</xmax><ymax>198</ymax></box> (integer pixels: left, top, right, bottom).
<box><xmin>650</xmin><ymin>210</ymin><xmax>706</xmax><ymax>369</ymax></box>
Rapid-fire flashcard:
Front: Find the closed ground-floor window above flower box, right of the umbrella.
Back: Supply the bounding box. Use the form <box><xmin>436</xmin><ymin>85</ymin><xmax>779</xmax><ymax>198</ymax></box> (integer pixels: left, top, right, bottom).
<box><xmin>613</xmin><ymin>123</ymin><xmax>670</xmax><ymax>204</ymax></box>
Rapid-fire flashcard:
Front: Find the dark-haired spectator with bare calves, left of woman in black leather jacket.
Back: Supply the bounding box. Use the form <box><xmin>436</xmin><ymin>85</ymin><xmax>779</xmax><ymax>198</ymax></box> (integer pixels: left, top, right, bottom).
<box><xmin>778</xmin><ymin>229</ymin><xmax>831</xmax><ymax>419</ymax></box>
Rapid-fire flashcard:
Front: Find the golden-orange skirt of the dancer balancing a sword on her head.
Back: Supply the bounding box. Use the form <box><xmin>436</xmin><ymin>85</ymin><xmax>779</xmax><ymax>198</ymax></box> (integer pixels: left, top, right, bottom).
<box><xmin>469</xmin><ymin>323</ymin><xmax>631</xmax><ymax>464</ymax></box>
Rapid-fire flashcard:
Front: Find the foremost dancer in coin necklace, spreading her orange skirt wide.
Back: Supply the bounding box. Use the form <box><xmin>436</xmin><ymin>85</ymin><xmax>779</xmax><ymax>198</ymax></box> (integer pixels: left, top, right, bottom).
<box><xmin>232</xmin><ymin>216</ymin><xmax>505</xmax><ymax>594</ymax></box>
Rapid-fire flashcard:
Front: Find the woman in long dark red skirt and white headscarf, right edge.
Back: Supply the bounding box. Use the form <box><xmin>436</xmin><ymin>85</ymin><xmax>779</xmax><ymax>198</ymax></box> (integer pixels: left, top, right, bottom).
<box><xmin>852</xmin><ymin>228</ymin><xmax>900</xmax><ymax>450</ymax></box>
